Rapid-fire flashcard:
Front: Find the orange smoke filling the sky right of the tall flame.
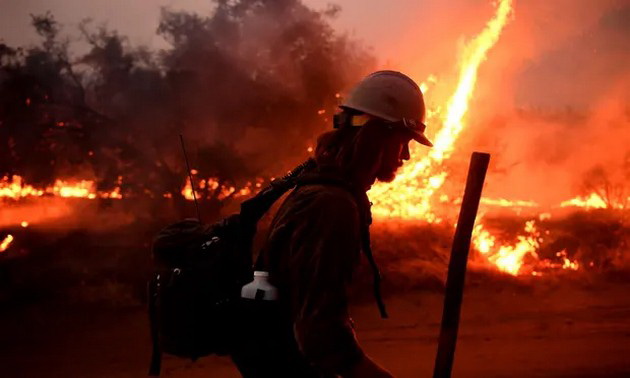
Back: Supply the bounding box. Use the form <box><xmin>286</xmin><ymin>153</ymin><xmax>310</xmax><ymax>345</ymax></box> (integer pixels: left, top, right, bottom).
<box><xmin>471</xmin><ymin>2</ymin><xmax>630</xmax><ymax>206</ymax></box>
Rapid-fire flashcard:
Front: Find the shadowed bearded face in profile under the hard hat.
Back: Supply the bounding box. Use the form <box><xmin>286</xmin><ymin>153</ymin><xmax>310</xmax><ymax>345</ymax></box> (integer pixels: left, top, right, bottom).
<box><xmin>376</xmin><ymin>130</ymin><xmax>412</xmax><ymax>182</ymax></box>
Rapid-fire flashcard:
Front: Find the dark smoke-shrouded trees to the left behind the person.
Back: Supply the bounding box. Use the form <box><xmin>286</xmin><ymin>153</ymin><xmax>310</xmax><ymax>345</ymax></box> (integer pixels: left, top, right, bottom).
<box><xmin>0</xmin><ymin>0</ymin><xmax>372</xmax><ymax>219</ymax></box>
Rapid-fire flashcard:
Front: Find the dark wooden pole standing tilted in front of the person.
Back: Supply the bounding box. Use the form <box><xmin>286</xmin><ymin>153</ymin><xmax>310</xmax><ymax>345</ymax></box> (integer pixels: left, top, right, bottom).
<box><xmin>433</xmin><ymin>152</ymin><xmax>490</xmax><ymax>378</ymax></box>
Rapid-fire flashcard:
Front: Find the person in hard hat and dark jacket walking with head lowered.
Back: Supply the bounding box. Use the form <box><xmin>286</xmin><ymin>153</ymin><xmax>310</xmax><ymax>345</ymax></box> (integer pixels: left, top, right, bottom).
<box><xmin>232</xmin><ymin>71</ymin><xmax>432</xmax><ymax>378</ymax></box>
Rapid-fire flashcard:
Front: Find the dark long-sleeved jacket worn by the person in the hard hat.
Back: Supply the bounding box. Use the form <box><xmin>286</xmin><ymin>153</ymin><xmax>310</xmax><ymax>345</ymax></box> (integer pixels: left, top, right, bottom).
<box><xmin>232</xmin><ymin>169</ymin><xmax>371</xmax><ymax>377</ymax></box>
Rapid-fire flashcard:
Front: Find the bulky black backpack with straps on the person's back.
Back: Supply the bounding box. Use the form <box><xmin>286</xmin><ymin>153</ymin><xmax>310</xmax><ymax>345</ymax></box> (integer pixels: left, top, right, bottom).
<box><xmin>148</xmin><ymin>159</ymin><xmax>387</xmax><ymax>376</ymax></box>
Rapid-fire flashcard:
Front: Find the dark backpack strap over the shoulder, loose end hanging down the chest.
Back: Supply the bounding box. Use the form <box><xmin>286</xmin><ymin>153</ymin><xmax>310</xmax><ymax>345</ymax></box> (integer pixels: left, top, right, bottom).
<box><xmin>297</xmin><ymin>172</ymin><xmax>388</xmax><ymax>319</ymax></box>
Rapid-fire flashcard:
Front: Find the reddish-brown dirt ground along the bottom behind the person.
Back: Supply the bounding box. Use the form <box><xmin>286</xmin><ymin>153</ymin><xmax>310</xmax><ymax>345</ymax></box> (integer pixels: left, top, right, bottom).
<box><xmin>0</xmin><ymin>281</ymin><xmax>630</xmax><ymax>378</ymax></box>
